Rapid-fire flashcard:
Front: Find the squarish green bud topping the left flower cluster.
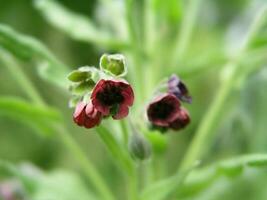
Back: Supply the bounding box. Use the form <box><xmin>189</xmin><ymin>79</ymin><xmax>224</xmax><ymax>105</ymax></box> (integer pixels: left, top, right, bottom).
<box><xmin>100</xmin><ymin>54</ymin><xmax>127</xmax><ymax>76</ymax></box>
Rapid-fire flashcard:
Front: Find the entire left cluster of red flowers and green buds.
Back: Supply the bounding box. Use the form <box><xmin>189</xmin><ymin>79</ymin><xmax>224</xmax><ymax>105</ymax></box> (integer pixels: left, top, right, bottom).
<box><xmin>68</xmin><ymin>54</ymin><xmax>134</xmax><ymax>128</ymax></box>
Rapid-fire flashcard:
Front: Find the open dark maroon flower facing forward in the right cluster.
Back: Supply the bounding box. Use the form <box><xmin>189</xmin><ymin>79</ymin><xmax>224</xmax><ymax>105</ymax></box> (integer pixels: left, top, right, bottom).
<box><xmin>147</xmin><ymin>93</ymin><xmax>180</xmax><ymax>127</ymax></box>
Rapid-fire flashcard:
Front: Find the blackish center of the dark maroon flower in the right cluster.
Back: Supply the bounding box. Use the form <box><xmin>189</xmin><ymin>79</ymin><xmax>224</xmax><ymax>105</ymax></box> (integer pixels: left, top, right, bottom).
<box><xmin>152</xmin><ymin>102</ymin><xmax>174</xmax><ymax>119</ymax></box>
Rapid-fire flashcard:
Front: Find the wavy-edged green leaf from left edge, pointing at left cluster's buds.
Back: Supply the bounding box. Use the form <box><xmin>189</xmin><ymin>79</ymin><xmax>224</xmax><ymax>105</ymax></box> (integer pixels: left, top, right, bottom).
<box><xmin>0</xmin><ymin>24</ymin><xmax>68</xmax><ymax>88</ymax></box>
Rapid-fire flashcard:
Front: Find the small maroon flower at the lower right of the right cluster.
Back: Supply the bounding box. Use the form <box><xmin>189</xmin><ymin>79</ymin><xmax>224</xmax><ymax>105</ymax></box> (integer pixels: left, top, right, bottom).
<box><xmin>170</xmin><ymin>108</ymin><xmax>190</xmax><ymax>130</ymax></box>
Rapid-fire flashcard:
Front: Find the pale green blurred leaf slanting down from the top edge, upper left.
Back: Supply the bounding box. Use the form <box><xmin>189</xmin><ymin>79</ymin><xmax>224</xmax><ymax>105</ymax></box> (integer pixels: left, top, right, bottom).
<box><xmin>34</xmin><ymin>0</ymin><xmax>127</xmax><ymax>49</ymax></box>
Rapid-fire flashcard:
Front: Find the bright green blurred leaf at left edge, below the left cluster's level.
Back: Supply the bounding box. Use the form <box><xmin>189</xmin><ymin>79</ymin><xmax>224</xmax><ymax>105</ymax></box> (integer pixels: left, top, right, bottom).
<box><xmin>0</xmin><ymin>96</ymin><xmax>61</xmax><ymax>136</ymax></box>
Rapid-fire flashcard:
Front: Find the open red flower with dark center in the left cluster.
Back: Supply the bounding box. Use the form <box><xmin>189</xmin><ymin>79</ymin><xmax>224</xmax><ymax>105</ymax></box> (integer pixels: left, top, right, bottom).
<box><xmin>91</xmin><ymin>79</ymin><xmax>134</xmax><ymax>119</ymax></box>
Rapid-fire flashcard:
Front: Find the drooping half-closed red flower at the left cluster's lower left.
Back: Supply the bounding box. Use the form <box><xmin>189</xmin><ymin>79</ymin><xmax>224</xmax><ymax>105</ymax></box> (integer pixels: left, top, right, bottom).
<box><xmin>73</xmin><ymin>101</ymin><xmax>102</xmax><ymax>128</ymax></box>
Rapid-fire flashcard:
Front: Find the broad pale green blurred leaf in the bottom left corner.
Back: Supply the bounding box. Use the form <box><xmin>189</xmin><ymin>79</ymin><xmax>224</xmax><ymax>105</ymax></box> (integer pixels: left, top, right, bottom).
<box><xmin>0</xmin><ymin>161</ymin><xmax>97</xmax><ymax>200</ymax></box>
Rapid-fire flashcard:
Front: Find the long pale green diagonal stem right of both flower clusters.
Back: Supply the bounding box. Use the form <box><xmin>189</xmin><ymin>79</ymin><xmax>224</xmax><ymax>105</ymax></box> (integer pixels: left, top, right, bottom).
<box><xmin>181</xmin><ymin>7</ymin><xmax>267</xmax><ymax>170</ymax></box>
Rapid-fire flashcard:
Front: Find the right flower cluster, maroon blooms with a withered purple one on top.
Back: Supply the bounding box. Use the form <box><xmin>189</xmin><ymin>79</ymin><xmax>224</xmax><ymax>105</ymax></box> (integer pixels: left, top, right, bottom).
<box><xmin>147</xmin><ymin>75</ymin><xmax>192</xmax><ymax>131</ymax></box>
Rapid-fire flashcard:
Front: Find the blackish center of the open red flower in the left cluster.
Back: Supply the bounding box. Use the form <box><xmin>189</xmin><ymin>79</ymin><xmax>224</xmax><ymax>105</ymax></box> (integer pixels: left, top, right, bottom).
<box><xmin>96</xmin><ymin>85</ymin><xmax>124</xmax><ymax>106</ymax></box>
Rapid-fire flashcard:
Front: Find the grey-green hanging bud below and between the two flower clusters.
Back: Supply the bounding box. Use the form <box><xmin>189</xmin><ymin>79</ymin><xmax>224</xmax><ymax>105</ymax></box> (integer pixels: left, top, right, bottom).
<box><xmin>128</xmin><ymin>132</ymin><xmax>151</xmax><ymax>160</ymax></box>
